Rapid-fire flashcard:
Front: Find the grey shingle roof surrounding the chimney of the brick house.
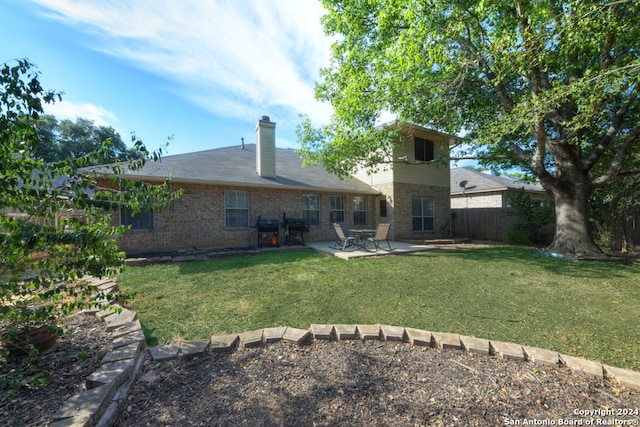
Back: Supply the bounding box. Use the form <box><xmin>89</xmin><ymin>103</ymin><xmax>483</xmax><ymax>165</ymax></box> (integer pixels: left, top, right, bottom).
<box><xmin>94</xmin><ymin>144</ymin><xmax>380</xmax><ymax>194</ymax></box>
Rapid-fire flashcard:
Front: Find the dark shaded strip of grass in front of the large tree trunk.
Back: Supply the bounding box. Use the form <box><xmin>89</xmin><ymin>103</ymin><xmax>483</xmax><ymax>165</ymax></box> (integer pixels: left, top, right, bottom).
<box><xmin>430</xmin><ymin>246</ymin><xmax>633</xmax><ymax>279</ymax></box>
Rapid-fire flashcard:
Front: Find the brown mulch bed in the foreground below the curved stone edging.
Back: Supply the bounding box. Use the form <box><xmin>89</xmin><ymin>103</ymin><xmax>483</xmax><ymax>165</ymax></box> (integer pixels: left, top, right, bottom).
<box><xmin>117</xmin><ymin>341</ymin><xmax>640</xmax><ymax>427</ymax></box>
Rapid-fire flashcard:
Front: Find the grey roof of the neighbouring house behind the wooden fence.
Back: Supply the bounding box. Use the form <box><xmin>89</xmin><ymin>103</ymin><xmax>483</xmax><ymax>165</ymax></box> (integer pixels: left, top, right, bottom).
<box><xmin>451</xmin><ymin>168</ymin><xmax>545</xmax><ymax>196</ymax></box>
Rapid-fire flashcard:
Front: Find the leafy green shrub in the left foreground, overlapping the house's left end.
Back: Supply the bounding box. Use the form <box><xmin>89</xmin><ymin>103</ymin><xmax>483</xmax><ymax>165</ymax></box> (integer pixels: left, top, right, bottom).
<box><xmin>0</xmin><ymin>60</ymin><xmax>179</xmax><ymax>354</ymax></box>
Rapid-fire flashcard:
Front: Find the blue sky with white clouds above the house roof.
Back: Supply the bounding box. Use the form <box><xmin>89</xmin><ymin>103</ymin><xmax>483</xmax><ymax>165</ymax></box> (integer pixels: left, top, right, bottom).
<box><xmin>0</xmin><ymin>0</ymin><xmax>331</xmax><ymax>155</ymax></box>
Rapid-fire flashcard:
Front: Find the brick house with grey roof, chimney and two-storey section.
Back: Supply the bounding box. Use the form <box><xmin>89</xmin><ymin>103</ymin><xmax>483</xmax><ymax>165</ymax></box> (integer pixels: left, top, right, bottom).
<box><xmin>95</xmin><ymin>116</ymin><xmax>453</xmax><ymax>252</ymax></box>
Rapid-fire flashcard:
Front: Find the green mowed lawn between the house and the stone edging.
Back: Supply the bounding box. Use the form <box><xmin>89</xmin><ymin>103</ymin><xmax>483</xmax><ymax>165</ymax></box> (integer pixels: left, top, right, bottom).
<box><xmin>118</xmin><ymin>246</ymin><xmax>640</xmax><ymax>370</ymax></box>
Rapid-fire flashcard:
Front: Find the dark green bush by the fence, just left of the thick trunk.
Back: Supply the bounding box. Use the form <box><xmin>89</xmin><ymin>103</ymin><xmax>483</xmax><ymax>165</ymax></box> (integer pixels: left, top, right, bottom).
<box><xmin>504</xmin><ymin>188</ymin><xmax>553</xmax><ymax>244</ymax></box>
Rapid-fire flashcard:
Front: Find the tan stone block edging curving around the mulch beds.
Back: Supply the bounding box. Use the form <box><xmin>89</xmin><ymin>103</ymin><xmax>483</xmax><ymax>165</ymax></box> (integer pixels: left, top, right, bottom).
<box><xmin>50</xmin><ymin>278</ymin><xmax>640</xmax><ymax>427</ymax></box>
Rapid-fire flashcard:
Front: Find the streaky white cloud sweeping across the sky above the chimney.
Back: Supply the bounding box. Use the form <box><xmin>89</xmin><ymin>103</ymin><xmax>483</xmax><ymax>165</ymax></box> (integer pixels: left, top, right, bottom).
<box><xmin>33</xmin><ymin>0</ymin><xmax>331</xmax><ymax>122</ymax></box>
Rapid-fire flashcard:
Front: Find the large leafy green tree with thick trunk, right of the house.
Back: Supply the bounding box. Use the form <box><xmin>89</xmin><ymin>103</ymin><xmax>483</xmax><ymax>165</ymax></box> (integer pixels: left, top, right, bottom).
<box><xmin>298</xmin><ymin>0</ymin><xmax>640</xmax><ymax>255</ymax></box>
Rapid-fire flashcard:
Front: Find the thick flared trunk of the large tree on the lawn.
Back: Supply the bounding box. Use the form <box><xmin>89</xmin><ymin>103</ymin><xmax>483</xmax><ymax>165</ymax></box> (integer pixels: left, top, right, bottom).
<box><xmin>548</xmin><ymin>176</ymin><xmax>602</xmax><ymax>257</ymax></box>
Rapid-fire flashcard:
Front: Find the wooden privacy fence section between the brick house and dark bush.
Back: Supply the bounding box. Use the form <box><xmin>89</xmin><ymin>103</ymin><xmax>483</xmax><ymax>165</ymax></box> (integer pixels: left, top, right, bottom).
<box><xmin>451</xmin><ymin>208</ymin><xmax>518</xmax><ymax>241</ymax></box>
